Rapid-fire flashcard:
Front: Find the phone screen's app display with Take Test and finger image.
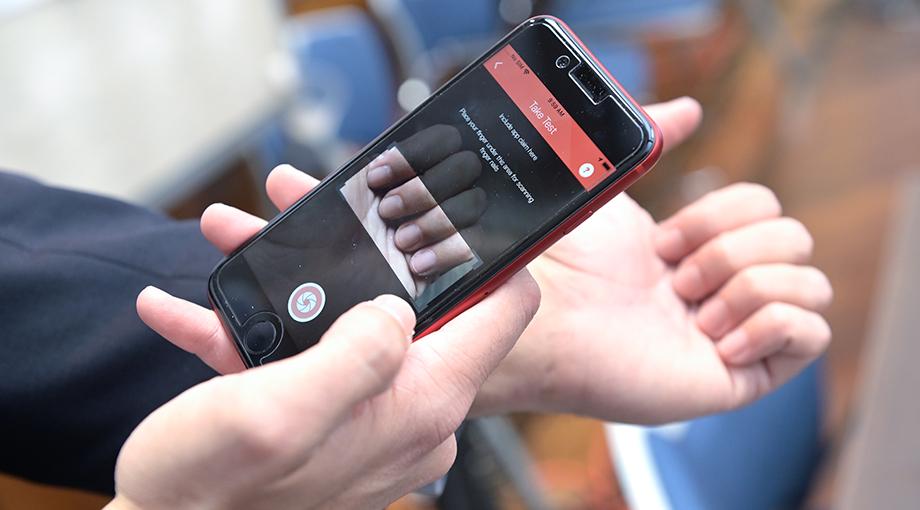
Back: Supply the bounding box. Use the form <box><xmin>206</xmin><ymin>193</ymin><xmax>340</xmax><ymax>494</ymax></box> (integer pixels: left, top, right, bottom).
<box><xmin>221</xmin><ymin>24</ymin><xmax>644</xmax><ymax>357</ymax></box>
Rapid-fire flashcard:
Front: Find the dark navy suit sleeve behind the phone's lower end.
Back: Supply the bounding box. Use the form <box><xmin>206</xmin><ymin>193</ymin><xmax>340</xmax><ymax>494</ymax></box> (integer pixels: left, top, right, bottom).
<box><xmin>0</xmin><ymin>173</ymin><xmax>220</xmax><ymax>493</ymax></box>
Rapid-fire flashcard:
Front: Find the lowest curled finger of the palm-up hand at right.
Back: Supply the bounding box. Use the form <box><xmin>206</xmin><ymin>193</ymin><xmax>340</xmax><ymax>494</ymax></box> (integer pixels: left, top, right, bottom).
<box><xmin>716</xmin><ymin>303</ymin><xmax>831</xmax><ymax>368</ymax></box>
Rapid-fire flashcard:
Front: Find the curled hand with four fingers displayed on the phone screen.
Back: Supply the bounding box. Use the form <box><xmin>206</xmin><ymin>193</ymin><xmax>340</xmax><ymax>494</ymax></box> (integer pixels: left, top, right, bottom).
<box><xmin>341</xmin><ymin>125</ymin><xmax>486</xmax><ymax>297</ymax></box>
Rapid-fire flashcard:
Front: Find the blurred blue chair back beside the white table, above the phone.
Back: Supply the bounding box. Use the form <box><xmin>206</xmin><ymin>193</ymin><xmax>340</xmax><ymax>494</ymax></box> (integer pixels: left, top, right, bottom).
<box><xmin>257</xmin><ymin>7</ymin><xmax>398</xmax><ymax>176</ymax></box>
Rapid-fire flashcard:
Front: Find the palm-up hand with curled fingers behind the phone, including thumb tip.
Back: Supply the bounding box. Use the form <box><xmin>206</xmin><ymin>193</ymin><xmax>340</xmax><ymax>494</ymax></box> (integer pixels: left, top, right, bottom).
<box><xmin>474</xmin><ymin>99</ymin><xmax>832</xmax><ymax>423</ymax></box>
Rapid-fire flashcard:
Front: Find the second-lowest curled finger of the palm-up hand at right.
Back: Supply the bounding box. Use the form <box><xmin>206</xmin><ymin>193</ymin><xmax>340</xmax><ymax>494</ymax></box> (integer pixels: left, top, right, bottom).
<box><xmin>696</xmin><ymin>264</ymin><xmax>834</xmax><ymax>338</ymax></box>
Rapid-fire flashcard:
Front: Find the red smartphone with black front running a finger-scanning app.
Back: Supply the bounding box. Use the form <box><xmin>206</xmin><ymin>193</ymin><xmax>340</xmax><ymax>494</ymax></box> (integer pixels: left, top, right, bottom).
<box><xmin>208</xmin><ymin>16</ymin><xmax>661</xmax><ymax>367</ymax></box>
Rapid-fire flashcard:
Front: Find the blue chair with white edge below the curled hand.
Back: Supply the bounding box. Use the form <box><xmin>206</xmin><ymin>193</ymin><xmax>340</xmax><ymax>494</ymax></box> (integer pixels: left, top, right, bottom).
<box><xmin>608</xmin><ymin>360</ymin><xmax>823</xmax><ymax>510</ymax></box>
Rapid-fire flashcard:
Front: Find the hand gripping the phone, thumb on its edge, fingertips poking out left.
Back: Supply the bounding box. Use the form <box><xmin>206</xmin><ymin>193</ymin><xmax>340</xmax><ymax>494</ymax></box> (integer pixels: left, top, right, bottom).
<box><xmin>124</xmin><ymin>167</ymin><xmax>539</xmax><ymax>508</ymax></box>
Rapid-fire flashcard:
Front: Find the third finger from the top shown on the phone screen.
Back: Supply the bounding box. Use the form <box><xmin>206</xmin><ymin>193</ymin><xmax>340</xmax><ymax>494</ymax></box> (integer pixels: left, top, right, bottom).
<box><xmin>395</xmin><ymin>188</ymin><xmax>486</xmax><ymax>253</ymax></box>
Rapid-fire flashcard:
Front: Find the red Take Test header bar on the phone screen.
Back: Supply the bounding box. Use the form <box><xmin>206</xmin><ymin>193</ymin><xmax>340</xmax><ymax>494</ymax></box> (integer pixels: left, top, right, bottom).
<box><xmin>485</xmin><ymin>44</ymin><xmax>614</xmax><ymax>191</ymax></box>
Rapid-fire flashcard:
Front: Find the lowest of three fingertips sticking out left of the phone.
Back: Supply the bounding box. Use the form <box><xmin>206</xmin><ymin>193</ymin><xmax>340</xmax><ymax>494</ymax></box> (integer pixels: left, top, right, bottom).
<box><xmin>137</xmin><ymin>287</ymin><xmax>245</xmax><ymax>374</ymax></box>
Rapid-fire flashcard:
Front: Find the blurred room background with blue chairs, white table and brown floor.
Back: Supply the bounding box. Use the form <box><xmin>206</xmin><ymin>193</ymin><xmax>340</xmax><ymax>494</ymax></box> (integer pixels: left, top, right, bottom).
<box><xmin>0</xmin><ymin>0</ymin><xmax>920</xmax><ymax>509</ymax></box>
